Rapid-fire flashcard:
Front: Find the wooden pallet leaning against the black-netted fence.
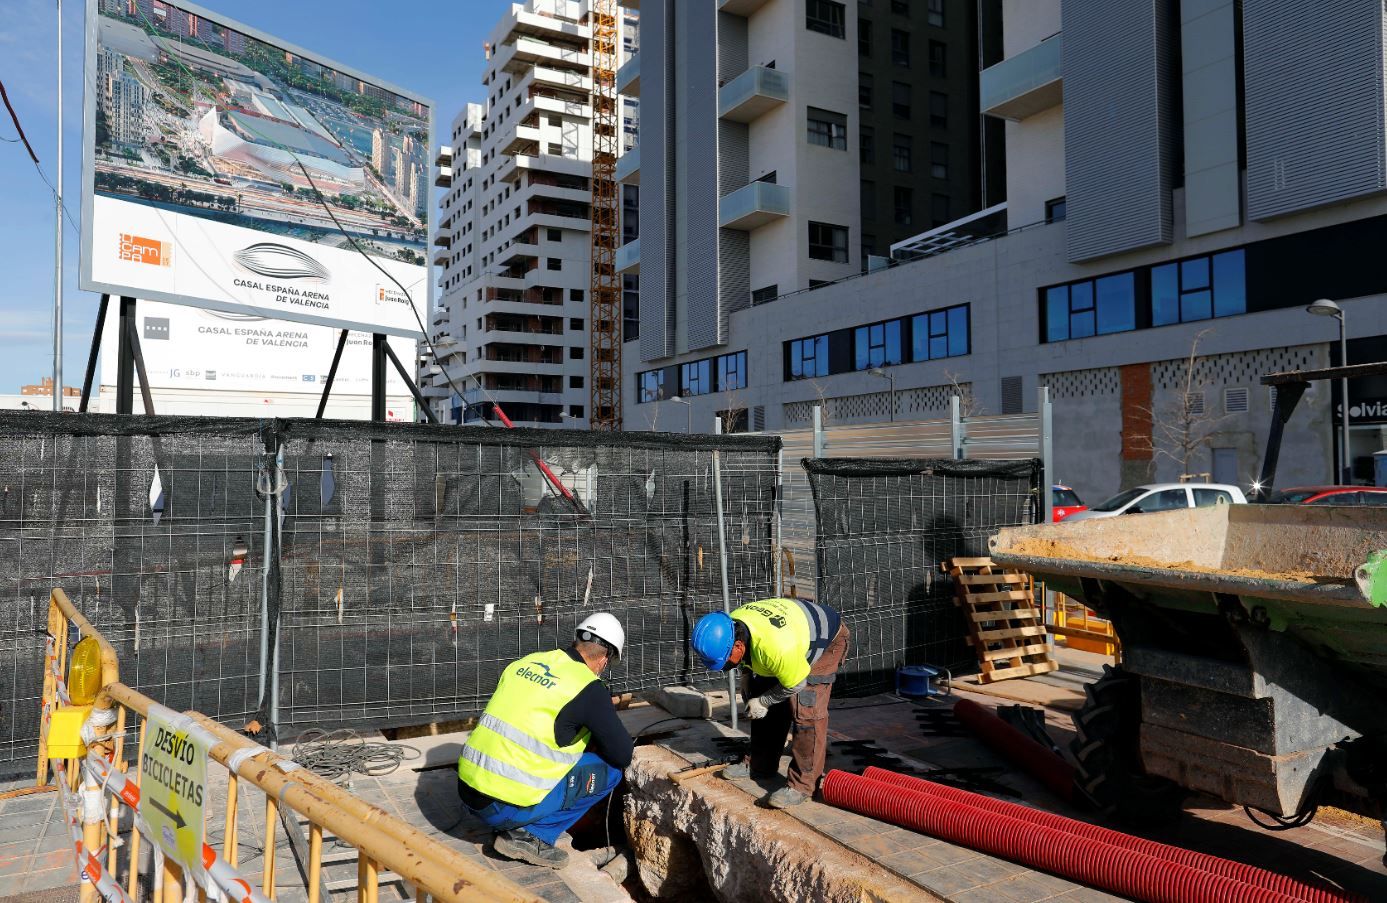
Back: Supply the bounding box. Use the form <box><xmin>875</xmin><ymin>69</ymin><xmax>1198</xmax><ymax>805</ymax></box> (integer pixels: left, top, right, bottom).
<box><xmin>943</xmin><ymin>558</ymin><xmax>1060</xmax><ymax>684</ymax></box>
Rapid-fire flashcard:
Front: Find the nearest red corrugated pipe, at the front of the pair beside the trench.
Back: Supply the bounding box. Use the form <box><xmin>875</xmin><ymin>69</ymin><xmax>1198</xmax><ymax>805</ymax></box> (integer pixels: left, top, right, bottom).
<box><xmin>822</xmin><ymin>768</ymin><xmax>1300</xmax><ymax>903</ymax></box>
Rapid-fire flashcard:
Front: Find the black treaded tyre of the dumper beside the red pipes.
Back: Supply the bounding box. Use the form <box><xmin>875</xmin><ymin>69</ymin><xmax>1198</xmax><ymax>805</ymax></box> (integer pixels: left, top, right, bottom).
<box><xmin>1069</xmin><ymin>664</ymin><xmax>1184</xmax><ymax>825</ymax></box>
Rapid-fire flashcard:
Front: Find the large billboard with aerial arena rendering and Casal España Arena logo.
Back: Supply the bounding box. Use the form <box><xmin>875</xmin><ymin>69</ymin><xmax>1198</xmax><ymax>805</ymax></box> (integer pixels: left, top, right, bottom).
<box><xmin>80</xmin><ymin>0</ymin><xmax>433</xmax><ymax>337</ymax></box>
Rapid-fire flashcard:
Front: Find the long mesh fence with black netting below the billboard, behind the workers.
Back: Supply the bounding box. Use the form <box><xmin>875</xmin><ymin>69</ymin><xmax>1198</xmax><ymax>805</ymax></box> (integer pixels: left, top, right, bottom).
<box><xmin>0</xmin><ymin>413</ymin><xmax>779</xmax><ymax>771</ymax></box>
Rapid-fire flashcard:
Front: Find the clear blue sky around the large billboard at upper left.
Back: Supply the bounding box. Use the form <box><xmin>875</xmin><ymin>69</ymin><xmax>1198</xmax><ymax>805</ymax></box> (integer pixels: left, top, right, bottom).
<box><xmin>0</xmin><ymin>0</ymin><xmax>490</xmax><ymax>394</ymax></box>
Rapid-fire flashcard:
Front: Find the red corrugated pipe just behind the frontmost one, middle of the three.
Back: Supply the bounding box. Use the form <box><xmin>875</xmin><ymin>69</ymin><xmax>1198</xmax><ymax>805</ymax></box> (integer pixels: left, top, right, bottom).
<box><xmin>863</xmin><ymin>766</ymin><xmax>1362</xmax><ymax>903</ymax></box>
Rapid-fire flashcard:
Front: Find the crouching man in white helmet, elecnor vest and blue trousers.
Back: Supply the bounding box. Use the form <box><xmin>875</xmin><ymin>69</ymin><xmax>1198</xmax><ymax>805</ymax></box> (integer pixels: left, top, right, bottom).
<box><xmin>458</xmin><ymin>612</ymin><xmax>634</xmax><ymax>868</ymax></box>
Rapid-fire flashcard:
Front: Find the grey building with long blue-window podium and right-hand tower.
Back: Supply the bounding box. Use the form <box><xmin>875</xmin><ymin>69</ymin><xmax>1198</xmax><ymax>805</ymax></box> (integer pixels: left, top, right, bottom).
<box><xmin>624</xmin><ymin>0</ymin><xmax>1387</xmax><ymax>501</ymax></box>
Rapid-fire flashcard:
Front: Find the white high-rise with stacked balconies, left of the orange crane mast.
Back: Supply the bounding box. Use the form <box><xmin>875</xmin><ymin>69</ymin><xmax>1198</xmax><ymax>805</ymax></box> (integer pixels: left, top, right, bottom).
<box><xmin>420</xmin><ymin>0</ymin><xmax>634</xmax><ymax>427</ymax></box>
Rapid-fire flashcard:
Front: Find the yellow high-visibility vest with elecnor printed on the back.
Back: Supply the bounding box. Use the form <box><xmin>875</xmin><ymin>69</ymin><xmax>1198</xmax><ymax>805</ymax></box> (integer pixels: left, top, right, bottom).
<box><xmin>458</xmin><ymin>649</ymin><xmax>598</xmax><ymax>806</ymax></box>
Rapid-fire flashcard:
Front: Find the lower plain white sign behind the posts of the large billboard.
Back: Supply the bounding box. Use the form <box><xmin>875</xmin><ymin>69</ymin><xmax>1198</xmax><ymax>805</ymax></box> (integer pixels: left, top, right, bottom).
<box><xmin>101</xmin><ymin>301</ymin><xmax>415</xmax><ymax>398</ymax></box>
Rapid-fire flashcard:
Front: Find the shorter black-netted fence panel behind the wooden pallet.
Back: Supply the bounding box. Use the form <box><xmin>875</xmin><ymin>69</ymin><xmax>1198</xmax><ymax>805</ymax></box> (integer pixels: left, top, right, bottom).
<box><xmin>803</xmin><ymin>458</ymin><xmax>1042</xmax><ymax>692</ymax></box>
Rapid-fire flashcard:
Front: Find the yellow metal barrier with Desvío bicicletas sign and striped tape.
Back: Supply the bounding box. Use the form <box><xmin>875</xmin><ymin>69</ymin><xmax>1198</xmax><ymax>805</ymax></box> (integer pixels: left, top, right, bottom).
<box><xmin>37</xmin><ymin>590</ymin><xmax>541</xmax><ymax>903</ymax></box>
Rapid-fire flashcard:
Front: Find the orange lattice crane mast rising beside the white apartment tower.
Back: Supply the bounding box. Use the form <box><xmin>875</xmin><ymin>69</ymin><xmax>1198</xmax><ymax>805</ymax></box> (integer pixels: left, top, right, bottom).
<box><xmin>588</xmin><ymin>0</ymin><xmax>621</xmax><ymax>431</ymax></box>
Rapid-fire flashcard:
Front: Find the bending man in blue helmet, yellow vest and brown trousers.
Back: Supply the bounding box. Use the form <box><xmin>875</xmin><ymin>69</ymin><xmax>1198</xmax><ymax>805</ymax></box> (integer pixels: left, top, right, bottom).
<box><xmin>691</xmin><ymin>599</ymin><xmax>849</xmax><ymax>809</ymax></box>
